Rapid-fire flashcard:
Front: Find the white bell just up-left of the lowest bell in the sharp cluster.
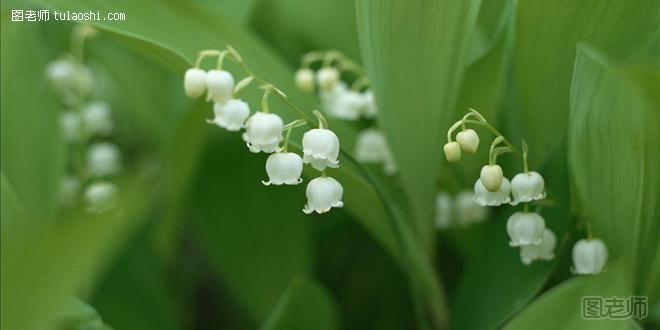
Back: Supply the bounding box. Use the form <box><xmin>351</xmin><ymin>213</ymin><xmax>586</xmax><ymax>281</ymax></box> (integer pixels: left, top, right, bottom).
<box><xmin>261</xmin><ymin>152</ymin><xmax>303</xmax><ymax>186</ymax></box>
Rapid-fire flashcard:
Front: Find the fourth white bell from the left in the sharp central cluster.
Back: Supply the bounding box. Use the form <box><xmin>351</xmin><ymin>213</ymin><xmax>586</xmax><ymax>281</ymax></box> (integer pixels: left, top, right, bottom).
<box><xmin>243</xmin><ymin>112</ymin><xmax>284</xmax><ymax>153</ymax></box>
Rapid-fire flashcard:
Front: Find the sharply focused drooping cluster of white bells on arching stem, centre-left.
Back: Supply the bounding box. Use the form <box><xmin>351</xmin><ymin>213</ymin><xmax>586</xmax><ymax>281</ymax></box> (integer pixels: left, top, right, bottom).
<box><xmin>184</xmin><ymin>46</ymin><xmax>344</xmax><ymax>214</ymax></box>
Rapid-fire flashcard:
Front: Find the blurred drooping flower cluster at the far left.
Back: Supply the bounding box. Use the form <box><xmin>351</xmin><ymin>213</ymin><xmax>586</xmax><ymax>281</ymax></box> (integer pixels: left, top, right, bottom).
<box><xmin>46</xmin><ymin>26</ymin><xmax>121</xmax><ymax>213</ymax></box>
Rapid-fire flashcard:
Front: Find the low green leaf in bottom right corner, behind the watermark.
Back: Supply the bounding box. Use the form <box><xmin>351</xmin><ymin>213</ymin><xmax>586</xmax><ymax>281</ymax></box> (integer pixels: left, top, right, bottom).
<box><xmin>504</xmin><ymin>260</ymin><xmax>639</xmax><ymax>330</ymax></box>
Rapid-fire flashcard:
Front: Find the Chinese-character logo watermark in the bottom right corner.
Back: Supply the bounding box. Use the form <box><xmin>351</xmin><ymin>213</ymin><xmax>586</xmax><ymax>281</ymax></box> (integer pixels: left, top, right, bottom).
<box><xmin>582</xmin><ymin>296</ymin><xmax>649</xmax><ymax>320</ymax></box>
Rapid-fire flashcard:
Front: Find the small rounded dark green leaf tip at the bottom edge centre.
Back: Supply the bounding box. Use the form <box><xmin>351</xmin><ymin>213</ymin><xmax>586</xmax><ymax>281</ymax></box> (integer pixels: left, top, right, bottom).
<box><xmin>260</xmin><ymin>276</ymin><xmax>341</xmax><ymax>330</ymax></box>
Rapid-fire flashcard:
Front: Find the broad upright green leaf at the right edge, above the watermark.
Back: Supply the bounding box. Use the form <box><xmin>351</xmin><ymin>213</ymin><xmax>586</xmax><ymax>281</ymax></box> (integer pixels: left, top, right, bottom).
<box><xmin>568</xmin><ymin>45</ymin><xmax>660</xmax><ymax>283</ymax></box>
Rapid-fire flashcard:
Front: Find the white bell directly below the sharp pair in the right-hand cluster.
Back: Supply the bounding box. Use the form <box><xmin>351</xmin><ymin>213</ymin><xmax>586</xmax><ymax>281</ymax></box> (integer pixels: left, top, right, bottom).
<box><xmin>506</xmin><ymin>212</ymin><xmax>545</xmax><ymax>246</ymax></box>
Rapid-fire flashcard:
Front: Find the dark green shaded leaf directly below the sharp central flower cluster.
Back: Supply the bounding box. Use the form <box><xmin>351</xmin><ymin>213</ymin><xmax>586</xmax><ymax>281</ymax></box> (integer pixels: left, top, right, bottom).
<box><xmin>190</xmin><ymin>135</ymin><xmax>314</xmax><ymax>324</ymax></box>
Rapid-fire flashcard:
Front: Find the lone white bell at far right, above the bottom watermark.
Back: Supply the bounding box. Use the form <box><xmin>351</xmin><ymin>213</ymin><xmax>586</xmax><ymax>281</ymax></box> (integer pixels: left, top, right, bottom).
<box><xmin>573</xmin><ymin>239</ymin><xmax>607</xmax><ymax>275</ymax></box>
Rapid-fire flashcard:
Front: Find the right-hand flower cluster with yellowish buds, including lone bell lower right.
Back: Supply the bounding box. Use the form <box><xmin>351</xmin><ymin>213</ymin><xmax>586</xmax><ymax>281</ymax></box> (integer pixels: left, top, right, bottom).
<box><xmin>444</xmin><ymin>109</ymin><xmax>607</xmax><ymax>274</ymax></box>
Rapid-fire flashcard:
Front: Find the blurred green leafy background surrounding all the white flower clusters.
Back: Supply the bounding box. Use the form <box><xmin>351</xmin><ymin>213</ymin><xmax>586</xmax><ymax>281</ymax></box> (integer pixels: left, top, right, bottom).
<box><xmin>0</xmin><ymin>0</ymin><xmax>660</xmax><ymax>330</ymax></box>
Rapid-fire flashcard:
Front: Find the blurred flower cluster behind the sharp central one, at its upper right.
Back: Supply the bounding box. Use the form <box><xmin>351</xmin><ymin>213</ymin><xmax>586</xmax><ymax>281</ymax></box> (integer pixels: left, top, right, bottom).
<box><xmin>295</xmin><ymin>51</ymin><xmax>397</xmax><ymax>175</ymax></box>
